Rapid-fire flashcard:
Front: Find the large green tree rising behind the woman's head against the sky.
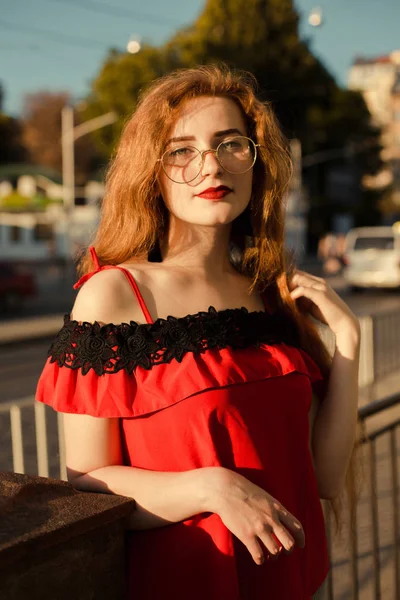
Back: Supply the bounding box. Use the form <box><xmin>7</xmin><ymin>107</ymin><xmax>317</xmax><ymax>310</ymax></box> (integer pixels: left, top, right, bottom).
<box><xmin>85</xmin><ymin>0</ymin><xmax>382</xmax><ymax>185</ymax></box>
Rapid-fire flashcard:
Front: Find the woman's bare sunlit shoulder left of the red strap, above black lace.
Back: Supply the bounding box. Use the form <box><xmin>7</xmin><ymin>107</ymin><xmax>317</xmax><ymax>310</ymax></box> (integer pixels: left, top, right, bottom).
<box><xmin>71</xmin><ymin>269</ymin><xmax>148</xmax><ymax>324</ymax></box>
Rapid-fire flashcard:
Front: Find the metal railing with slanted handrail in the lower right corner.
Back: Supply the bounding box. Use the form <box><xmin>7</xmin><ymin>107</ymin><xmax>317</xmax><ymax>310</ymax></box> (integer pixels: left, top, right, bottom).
<box><xmin>326</xmin><ymin>392</ymin><xmax>400</xmax><ymax>600</ymax></box>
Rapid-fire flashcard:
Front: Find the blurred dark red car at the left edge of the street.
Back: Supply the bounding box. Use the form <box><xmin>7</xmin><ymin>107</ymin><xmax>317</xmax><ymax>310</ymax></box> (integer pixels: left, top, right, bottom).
<box><xmin>0</xmin><ymin>262</ymin><xmax>37</xmax><ymax>312</ymax></box>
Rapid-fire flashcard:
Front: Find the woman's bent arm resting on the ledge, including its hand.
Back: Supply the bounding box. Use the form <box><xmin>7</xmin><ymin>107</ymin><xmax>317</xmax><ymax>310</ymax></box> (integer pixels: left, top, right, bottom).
<box><xmin>63</xmin><ymin>413</ymin><xmax>304</xmax><ymax>564</ymax></box>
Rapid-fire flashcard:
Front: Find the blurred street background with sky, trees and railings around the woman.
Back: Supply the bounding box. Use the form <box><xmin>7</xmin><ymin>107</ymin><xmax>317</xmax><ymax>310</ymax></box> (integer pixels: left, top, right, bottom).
<box><xmin>0</xmin><ymin>0</ymin><xmax>400</xmax><ymax>600</ymax></box>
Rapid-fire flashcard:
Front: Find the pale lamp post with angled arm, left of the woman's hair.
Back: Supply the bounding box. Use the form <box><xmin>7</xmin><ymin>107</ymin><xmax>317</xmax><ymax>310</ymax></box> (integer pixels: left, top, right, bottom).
<box><xmin>61</xmin><ymin>106</ymin><xmax>117</xmax><ymax>268</ymax></box>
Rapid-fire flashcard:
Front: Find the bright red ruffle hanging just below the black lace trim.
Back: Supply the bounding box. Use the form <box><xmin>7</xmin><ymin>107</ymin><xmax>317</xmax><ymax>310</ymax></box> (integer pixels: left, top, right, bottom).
<box><xmin>36</xmin><ymin>343</ymin><xmax>323</xmax><ymax>418</ymax></box>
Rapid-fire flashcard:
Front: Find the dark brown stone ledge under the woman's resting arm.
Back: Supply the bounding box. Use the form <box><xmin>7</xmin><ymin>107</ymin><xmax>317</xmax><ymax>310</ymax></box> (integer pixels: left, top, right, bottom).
<box><xmin>0</xmin><ymin>473</ymin><xmax>134</xmax><ymax>600</ymax></box>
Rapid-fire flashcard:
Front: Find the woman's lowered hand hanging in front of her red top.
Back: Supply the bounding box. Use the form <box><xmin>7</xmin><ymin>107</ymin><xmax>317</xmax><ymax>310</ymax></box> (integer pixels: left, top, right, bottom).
<box><xmin>202</xmin><ymin>467</ymin><xmax>305</xmax><ymax>565</ymax></box>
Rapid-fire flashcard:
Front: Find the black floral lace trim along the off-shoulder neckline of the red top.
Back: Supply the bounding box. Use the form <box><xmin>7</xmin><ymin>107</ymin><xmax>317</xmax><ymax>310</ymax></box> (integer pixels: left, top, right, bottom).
<box><xmin>48</xmin><ymin>306</ymin><xmax>299</xmax><ymax>375</ymax></box>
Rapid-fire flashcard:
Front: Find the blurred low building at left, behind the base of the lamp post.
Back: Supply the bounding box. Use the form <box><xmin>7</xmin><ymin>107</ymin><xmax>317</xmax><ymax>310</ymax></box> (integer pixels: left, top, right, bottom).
<box><xmin>0</xmin><ymin>165</ymin><xmax>104</xmax><ymax>263</ymax></box>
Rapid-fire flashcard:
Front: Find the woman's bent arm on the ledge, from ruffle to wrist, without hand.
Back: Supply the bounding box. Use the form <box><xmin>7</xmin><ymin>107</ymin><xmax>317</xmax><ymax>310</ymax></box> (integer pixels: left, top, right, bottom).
<box><xmin>63</xmin><ymin>413</ymin><xmax>223</xmax><ymax>529</ymax></box>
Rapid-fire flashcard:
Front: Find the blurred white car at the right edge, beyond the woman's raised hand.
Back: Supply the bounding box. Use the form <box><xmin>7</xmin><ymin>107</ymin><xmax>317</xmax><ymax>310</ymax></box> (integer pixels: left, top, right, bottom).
<box><xmin>343</xmin><ymin>223</ymin><xmax>400</xmax><ymax>291</ymax></box>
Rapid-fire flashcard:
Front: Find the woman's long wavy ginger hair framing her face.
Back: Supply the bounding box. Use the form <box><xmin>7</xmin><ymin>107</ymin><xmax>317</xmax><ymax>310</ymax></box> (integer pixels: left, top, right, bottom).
<box><xmin>78</xmin><ymin>65</ymin><xmax>355</xmax><ymax>525</ymax></box>
